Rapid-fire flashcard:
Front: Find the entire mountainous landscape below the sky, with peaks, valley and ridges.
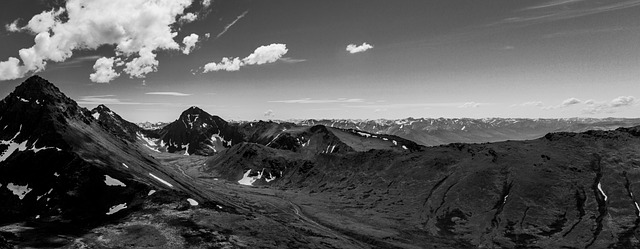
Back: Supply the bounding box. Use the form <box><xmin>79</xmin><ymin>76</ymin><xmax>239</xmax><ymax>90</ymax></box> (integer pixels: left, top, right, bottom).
<box><xmin>0</xmin><ymin>76</ymin><xmax>640</xmax><ymax>248</ymax></box>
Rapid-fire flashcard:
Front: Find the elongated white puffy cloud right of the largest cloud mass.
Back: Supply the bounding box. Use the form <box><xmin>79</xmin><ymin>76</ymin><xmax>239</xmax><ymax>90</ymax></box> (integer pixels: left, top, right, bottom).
<box><xmin>204</xmin><ymin>43</ymin><xmax>289</xmax><ymax>73</ymax></box>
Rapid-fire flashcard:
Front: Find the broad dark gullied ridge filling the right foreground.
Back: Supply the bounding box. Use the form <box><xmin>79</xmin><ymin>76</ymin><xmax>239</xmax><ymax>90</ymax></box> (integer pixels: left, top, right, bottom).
<box><xmin>209</xmin><ymin>124</ymin><xmax>640</xmax><ymax>248</ymax></box>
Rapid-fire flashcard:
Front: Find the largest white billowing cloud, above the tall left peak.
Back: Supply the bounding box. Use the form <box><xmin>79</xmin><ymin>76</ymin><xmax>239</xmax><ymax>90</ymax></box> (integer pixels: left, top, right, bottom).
<box><xmin>0</xmin><ymin>0</ymin><xmax>193</xmax><ymax>80</ymax></box>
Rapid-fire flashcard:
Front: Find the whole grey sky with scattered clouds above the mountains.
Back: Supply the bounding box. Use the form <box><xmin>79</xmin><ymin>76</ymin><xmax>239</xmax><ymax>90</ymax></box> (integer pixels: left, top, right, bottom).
<box><xmin>0</xmin><ymin>0</ymin><xmax>640</xmax><ymax>122</ymax></box>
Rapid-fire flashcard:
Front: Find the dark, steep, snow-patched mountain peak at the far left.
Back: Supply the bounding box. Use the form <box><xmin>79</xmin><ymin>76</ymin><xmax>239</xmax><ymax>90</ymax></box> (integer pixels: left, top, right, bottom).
<box><xmin>0</xmin><ymin>76</ymin><xmax>190</xmax><ymax>223</ymax></box>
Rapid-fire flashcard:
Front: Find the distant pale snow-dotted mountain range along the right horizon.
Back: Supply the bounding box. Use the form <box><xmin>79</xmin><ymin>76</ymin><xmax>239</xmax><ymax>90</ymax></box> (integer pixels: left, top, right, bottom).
<box><xmin>295</xmin><ymin>118</ymin><xmax>640</xmax><ymax>146</ymax></box>
